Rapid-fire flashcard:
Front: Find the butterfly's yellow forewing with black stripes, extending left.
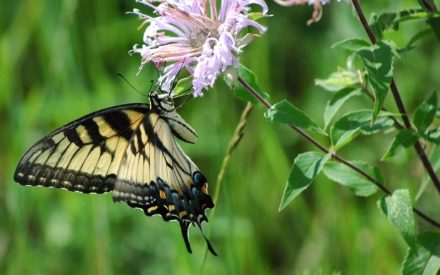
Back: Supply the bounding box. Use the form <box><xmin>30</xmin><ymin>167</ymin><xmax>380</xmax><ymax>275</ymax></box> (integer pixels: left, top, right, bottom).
<box><xmin>14</xmin><ymin>104</ymin><xmax>149</xmax><ymax>193</ymax></box>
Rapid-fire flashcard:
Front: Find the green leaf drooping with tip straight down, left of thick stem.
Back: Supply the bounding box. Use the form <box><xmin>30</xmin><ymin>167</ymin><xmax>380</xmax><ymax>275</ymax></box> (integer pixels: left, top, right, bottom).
<box><xmin>357</xmin><ymin>41</ymin><xmax>396</xmax><ymax>121</ymax></box>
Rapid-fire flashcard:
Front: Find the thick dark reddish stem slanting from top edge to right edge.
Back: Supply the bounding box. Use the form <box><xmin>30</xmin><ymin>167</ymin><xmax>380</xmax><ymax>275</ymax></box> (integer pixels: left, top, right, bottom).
<box><xmin>352</xmin><ymin>0</ymin><xmax>440</xmax><ymax>193</ymax></box>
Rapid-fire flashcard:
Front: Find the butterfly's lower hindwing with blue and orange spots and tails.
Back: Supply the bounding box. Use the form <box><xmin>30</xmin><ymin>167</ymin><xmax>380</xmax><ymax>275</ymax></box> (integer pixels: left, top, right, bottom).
<box><xmin>113</xmin><ymin>113</ymin><xmax>215</xmax><ymax>254</ymax></box>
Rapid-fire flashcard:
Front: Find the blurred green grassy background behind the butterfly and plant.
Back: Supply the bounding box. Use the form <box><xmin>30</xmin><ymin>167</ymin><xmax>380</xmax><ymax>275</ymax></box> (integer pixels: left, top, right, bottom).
<box><xmin>0</xmin><ymin>0</ymin><xmax>440</xmax><ymax>275</ymax></box>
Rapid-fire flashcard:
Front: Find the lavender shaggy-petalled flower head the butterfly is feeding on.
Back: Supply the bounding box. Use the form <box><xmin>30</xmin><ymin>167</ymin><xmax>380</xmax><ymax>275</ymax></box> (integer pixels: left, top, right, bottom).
<box><xmin>131</xmin><ymin>0</ymin><xmax>268</xmax><ymax>96</ymax></box>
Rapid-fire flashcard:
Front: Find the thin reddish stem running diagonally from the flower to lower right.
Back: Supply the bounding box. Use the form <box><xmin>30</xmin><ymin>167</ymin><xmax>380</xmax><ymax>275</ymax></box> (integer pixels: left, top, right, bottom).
<box><xmin>238</xmin><ymin>76</ymin><xmax>440</xmax><ymax>228</ymax></box>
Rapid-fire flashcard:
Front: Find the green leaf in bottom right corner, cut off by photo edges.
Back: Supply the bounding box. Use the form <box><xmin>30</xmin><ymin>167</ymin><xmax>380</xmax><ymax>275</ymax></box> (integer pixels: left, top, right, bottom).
<box><xmin>401</xmin><ymin>232</ymin><xmax>440</xmax><ymax>275</ymax></box>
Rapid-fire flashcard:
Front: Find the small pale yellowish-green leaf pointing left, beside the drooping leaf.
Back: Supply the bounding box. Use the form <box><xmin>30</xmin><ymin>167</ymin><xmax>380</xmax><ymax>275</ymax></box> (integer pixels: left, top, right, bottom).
<box><xmin>315</xmin><ymin>68</ymin><xmax>361</xmax><ymax>92</ymax></box>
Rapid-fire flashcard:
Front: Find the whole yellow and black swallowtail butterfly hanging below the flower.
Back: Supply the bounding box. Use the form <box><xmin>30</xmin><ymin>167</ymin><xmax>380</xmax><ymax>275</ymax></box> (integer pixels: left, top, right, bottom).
<box><xmin>14</xmin><ymin>93</ymin><xmax>216</xmax><ymax>254</ymax></box>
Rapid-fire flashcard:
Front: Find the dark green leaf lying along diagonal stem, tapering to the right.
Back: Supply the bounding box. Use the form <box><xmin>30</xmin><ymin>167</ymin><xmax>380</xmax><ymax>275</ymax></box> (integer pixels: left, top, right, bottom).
<box><xmin>264</xmin><ymin>99</ymin><xmax>327</xmax><ymax>136</ymax></box>
